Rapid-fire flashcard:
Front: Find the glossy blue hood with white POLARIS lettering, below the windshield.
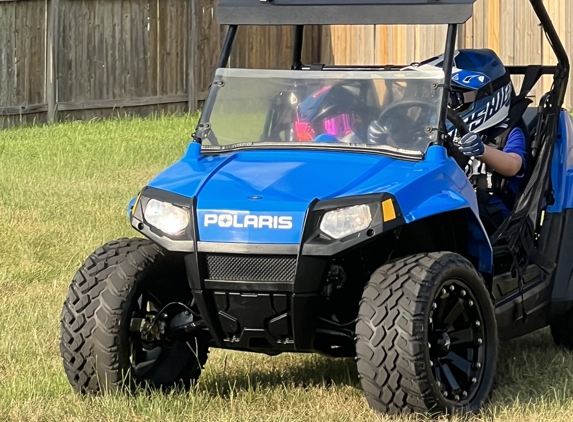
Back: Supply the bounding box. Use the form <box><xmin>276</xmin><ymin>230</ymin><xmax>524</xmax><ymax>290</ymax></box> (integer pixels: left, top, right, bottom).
<box><xmin>145</xmin><ymin>147</ymin><xmax>475</xmax><ymax>244</ymax></box>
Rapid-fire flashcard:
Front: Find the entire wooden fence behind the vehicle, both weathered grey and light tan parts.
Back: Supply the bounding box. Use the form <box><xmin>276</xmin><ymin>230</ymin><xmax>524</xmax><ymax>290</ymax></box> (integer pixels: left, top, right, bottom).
<box><xmin>0</xmin><ymin>0</ymin><xmax>573</xmax><ymax>127</ymax></box>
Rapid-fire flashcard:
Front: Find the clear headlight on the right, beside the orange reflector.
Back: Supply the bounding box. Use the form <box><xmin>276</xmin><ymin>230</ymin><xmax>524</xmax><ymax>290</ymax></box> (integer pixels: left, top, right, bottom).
<box><xmin>320</xmin><ymin>205</ymin><xmax>372</xmax><ymax>239</ymax></box>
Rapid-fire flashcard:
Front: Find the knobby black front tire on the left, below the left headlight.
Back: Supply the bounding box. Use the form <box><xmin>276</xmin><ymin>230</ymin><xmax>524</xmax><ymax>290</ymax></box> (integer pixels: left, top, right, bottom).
<box><xmin>60</xmin><ymin>238</ymin><xmax>207</xmax><ymax>393</ymax></box>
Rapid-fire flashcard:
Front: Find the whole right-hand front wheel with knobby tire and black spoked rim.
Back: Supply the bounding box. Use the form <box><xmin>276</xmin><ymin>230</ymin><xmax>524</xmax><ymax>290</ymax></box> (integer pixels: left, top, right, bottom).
<box><xmin>356</xmin><ymin>252</ymin><xmax>498</xmax><ymax>414</ymax></box>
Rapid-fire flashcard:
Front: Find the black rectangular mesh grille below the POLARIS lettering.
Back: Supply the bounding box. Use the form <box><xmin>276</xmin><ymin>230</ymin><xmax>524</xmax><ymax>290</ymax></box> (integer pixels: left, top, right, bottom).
<box><xmin>206</xmin><ymin>253</ymin><xmax>296</xmax><ymax>281</ymax></box>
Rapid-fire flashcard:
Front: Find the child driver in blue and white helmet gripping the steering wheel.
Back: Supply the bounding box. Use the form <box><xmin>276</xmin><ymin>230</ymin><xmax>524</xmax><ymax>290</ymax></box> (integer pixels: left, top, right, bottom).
<box><xmin>422</xmin><ymin>49</ymin><xmax>527</xmax><ymax>235</ymax></box>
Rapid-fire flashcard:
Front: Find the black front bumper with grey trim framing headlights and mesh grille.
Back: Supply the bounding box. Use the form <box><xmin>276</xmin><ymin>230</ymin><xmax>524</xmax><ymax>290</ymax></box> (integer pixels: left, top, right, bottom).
<box><xmin>130</xmin><ymin>188</ymin><xmax>403</xmax><ymax>353</ymax></box>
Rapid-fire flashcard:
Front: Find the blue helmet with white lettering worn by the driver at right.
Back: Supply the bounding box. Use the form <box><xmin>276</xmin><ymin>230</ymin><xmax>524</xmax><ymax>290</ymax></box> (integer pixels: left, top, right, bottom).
<box><xmin>419</xmin><ymin>49</ymin><xmax>514</xmax><ymax>132</ymax></box>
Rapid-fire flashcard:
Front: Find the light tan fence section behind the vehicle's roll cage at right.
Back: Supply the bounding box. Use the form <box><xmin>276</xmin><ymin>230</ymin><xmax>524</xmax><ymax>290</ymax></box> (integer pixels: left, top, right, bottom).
<box><xmin>322</xmin><ymin>0</ymin><xmax>573</xmax><ymax>108</ymax></box>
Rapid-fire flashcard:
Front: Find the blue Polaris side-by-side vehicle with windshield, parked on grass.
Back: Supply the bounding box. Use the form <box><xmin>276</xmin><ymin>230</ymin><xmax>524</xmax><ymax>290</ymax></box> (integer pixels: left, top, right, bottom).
<box><xmin>61</xmin><ymin>0</ymin><xmax>573</xmax><ymax>413</ymax></box>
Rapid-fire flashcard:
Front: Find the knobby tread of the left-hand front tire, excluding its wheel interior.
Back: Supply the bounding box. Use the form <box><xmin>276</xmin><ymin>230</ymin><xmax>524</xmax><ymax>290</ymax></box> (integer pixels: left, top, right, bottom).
<box><xmin>60</xmin><ymin>238</ymin><xmax>207</xmax><ymax>394</ymax></box>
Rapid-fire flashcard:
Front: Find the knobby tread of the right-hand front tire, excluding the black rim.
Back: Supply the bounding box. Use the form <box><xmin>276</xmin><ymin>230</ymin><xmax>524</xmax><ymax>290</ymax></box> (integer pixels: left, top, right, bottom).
<box><xmin>356</xmin><ymin>252</ymin><xmax>493</xmax><ymax>415</ymax></box>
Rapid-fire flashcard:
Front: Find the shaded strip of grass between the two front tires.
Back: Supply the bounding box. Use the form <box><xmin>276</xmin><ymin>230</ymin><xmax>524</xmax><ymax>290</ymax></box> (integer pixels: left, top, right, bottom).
<box><xmin>198</xmin><ymin>355</ymin><xmax>360</xmax><ymax>397</ymax></box>
